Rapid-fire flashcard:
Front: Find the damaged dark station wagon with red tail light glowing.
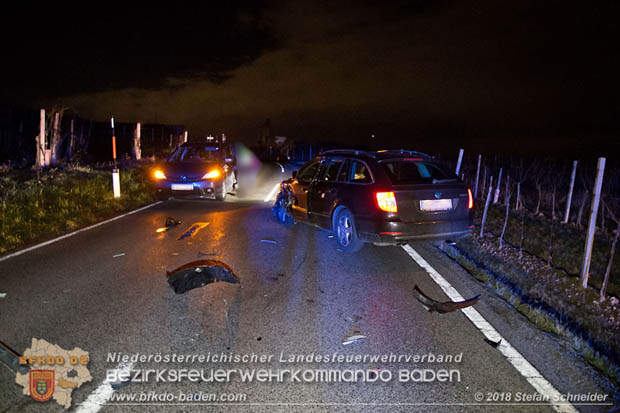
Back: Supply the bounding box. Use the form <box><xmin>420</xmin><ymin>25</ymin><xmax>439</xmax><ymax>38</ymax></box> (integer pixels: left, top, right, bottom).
<box><xmin>272</xmin><ymin>150</ymin><xmax>473</xmax><ymax>252</ymax></box>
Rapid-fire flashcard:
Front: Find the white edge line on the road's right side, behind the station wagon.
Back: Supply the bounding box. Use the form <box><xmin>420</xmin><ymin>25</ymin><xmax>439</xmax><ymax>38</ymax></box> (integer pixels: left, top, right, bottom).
<box><xmin>403</xmin><ymin>245</ymin><xmax>577</xmax><ymax>413</ymax></box>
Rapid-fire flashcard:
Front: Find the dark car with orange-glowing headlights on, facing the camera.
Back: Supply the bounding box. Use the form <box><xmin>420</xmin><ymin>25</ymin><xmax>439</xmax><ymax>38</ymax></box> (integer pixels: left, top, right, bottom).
<box><xmin>153</xmin><ymin>142</ymin><xmax>237</xmax><ymax>201</ymax></box>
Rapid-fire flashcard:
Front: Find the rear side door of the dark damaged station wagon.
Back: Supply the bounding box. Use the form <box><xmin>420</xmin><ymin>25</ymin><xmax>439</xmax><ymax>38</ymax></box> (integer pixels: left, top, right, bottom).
<box><xmin>308</xmin><ymin>157</ymin><xmax>345</xmax><ymax>228</ymax></box>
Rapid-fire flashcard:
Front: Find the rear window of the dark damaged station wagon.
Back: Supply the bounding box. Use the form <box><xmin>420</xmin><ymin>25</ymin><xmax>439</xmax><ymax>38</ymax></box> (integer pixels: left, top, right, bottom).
<box><xmin>383</xmin><ymin>160</ymin><xmax>457</xmax><ymax>185</ymax></box>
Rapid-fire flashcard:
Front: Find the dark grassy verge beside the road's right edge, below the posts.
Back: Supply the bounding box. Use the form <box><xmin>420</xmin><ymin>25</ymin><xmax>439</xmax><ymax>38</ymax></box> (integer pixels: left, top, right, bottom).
<box><xmin>440</xmin><ymin>236</ymin><xmax>620</xmax><ymax>387</ymax></box>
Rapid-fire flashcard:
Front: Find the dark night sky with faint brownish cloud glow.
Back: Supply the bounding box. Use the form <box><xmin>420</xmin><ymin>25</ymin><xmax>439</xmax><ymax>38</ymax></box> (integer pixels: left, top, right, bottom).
<box><xmin>0</xmin><ymin>0</ymin><xmax>620</xmax><ymax>155</ymax></box>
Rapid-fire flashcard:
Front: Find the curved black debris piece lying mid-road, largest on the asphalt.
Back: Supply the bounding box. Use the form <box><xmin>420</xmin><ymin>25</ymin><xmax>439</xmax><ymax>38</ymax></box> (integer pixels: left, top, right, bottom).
<box><xmin>167</xmin><ymin>260</ymin><xmax>240</xmax><ymax>294</ymax></box>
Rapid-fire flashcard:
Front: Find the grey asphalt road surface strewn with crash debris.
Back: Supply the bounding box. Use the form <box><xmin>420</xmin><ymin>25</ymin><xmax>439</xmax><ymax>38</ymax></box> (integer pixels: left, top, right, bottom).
<box><xmin>0</xmin><ymin>165</ymin><xmax>610</xmax><ymax>412</ymax></box>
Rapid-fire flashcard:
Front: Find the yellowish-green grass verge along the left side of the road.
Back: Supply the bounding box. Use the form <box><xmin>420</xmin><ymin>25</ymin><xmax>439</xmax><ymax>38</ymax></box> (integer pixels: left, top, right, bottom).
<box><xmin>0</xmin><ymin>165</ymin><xmax>155</xmax><ymax>254</ymax></box>
